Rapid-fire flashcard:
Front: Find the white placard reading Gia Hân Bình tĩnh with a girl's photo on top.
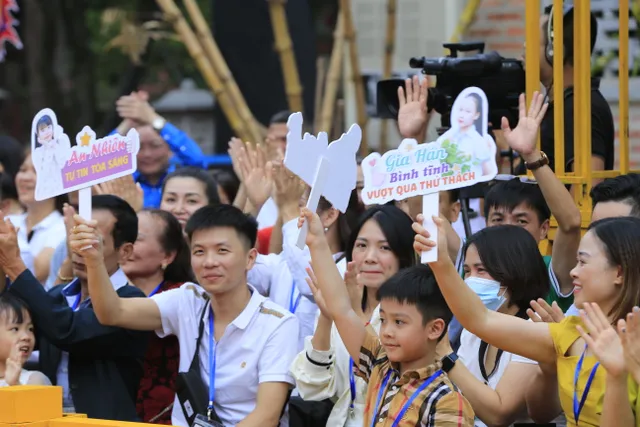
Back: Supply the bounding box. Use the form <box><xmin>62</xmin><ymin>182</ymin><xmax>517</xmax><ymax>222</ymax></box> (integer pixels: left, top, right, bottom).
<box><xmin>362</xmin><ymin>87</ymin><xmax>498</xmax><ymax>262</ymax></box>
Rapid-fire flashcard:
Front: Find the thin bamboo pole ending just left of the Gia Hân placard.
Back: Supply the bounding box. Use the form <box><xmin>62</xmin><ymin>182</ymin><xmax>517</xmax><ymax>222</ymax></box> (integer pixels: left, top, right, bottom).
<box><xmin>340</xmin><ymin>0</ymin><xmax>369</xmax><ymax>156</ymax></box>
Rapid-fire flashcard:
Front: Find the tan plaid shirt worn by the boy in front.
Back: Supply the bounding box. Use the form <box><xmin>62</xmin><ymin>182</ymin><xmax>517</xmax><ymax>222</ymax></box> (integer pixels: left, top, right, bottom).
<box><xmin>355</xmin><ymin>331</ymin><xmax>474</xmax><ymax>427</ymax></box>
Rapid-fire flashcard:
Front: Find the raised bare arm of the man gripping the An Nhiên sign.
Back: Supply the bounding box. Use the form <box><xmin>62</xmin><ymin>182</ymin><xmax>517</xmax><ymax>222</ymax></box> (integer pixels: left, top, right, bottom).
<box><xmin>69</xmin><ymin>215</ymin><xmax>162</xmax><ymax>331</ymax></box>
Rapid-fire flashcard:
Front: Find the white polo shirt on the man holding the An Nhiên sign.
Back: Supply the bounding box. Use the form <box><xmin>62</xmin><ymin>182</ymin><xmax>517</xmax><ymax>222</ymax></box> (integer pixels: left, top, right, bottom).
<box><xmin>151</xmin><ymin>283</ymin><xmax>298</xmax><ymax>427</ymax></box>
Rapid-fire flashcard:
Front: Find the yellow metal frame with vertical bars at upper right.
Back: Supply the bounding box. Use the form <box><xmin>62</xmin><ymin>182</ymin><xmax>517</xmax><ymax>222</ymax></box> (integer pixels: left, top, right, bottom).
<box><xmin>525</xmin><ymin>0</ymin><xmax>630</xmax><ymax>253</ymax></box>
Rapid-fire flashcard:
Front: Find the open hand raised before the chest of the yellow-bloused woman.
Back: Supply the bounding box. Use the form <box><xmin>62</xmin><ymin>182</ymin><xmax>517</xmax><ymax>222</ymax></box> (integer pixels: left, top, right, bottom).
<box><xmin>577</xmin><ymin>303</ymin><xmax>626</xmax><ymax>377</ymax></box>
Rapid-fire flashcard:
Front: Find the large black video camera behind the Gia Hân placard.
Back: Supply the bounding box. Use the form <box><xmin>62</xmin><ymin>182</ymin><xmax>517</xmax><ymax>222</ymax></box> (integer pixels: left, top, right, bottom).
<box><xmin>376</xmin><ymin>42</ymin><xmax>526</xmax><ymax>129</ymax></box>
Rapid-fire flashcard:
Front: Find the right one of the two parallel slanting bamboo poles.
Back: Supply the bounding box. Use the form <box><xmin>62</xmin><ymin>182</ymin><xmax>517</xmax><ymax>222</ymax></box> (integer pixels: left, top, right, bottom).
<box><xmin>181</xmin><ymin>0</ymin><xmax>266</xmax><ymax>143</ymax></box>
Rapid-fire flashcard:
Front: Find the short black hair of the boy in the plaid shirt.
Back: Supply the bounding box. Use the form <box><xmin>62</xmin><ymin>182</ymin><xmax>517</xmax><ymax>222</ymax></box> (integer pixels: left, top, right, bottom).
<box><xmin>376</xmin><ymin>264</ymin><xmax>453</xmax><ymax>332</ymax></box>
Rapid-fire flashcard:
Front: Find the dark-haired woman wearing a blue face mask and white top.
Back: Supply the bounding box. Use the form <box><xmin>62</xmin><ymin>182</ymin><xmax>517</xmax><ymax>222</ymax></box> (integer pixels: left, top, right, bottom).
<box><xmin>438</xmin><ymin>225</ymin><xmax>564</xmax><ymax>427</ymax></box>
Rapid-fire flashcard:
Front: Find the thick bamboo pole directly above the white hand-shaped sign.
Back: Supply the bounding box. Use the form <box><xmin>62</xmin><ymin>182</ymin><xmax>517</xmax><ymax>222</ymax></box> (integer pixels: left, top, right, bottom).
<box><xmin>266</xmin><ymin>0</ymin><xmax>304</xmax><ymax>112</ymax></box>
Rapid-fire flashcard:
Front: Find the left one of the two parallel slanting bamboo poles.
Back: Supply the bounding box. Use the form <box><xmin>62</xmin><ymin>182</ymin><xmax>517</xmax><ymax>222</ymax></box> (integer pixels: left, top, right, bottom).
<box><xmin>156</xmin><ymin>0</ymin><xmax>251</xmax><ymax>140</ymax></box>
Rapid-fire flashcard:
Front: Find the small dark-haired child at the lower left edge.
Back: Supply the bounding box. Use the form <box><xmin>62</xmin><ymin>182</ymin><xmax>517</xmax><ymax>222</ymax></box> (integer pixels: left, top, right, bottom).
<box><xmin>0</xmin><ymin>294</ymin><xmax>51</xmax><ymax>387</ymax></box>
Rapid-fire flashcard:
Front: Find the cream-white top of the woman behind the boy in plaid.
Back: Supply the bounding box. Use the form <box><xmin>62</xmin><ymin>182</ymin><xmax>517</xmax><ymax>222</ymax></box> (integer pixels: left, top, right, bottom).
<box><xmin>291</xmin><ymin>305</ymin><xmax>380</xmax><ymax>427</ymax></box>
